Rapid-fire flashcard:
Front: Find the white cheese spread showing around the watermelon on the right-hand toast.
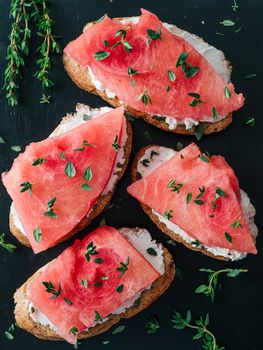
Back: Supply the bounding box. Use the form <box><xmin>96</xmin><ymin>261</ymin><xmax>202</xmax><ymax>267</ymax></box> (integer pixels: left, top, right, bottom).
<box><xmin>137</xmin><ymin>146</ymin><xmax>258</xmax><ymax>261</ymax></box>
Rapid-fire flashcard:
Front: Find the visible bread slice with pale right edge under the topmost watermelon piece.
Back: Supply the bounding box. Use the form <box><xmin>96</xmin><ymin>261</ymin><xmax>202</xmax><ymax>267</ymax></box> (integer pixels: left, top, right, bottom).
<box><xmin>63</xmin><ymin>17</ymin><xmax>232</xmax><ymax>135</ymax></box>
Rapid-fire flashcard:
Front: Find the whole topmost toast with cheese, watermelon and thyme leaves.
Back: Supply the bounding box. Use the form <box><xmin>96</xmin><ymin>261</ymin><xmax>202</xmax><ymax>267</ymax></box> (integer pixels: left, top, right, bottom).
<box><xmin>63</xmin><ymin>10</ymin><xmax>244</xmax><ymax>134</ymax></box>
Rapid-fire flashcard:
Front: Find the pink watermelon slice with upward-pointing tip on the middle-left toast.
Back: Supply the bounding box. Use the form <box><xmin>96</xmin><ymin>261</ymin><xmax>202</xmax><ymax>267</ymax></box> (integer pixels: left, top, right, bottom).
<box><xmin>2</xmin><ymin>107</ymin><xmax>125</xmax><ymax>253</ymax></box>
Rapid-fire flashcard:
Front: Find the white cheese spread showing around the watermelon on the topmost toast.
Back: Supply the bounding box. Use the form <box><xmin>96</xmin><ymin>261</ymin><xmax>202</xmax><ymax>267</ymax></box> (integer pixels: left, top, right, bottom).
<box><xmin>88</xmin><ymin>16</ymin><xmax>231</xmax><ymax>130</ymax></box>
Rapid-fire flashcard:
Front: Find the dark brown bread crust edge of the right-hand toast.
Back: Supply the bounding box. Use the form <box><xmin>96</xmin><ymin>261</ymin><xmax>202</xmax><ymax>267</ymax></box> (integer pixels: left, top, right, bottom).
<box><xmin>131</xmin><ymin>145</ymin><xmax>230</xmax><ymax>261</ymax></box>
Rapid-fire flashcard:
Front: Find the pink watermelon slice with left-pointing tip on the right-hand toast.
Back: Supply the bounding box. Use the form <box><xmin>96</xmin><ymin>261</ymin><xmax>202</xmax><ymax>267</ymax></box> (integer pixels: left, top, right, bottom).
<box><xmin>128</xmin><ymin>144</ymin><xmax>257</xmax><ymax>253</ymax></box>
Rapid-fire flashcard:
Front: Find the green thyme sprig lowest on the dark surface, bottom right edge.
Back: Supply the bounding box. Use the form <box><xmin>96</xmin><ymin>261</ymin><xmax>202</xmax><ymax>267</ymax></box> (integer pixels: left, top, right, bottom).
<box><xmin>171</xmin><ymin>310</ymin><xmax>225</xmax><ymax>350</ymax></box>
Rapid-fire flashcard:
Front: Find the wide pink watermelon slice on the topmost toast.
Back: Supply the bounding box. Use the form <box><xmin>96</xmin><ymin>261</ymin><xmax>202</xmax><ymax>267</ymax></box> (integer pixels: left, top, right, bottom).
<box><xmin>64</xmin><ymin>10</ymin><xmax>244</xmax><ymax>122</ymax></box>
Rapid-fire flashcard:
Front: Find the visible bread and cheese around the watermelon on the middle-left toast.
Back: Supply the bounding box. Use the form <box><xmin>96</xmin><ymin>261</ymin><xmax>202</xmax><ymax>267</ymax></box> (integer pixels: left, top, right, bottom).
<box><xmin>9</xmin><ymin>104</ymin><xmax>132</xmax><ymax>247</ymax></box>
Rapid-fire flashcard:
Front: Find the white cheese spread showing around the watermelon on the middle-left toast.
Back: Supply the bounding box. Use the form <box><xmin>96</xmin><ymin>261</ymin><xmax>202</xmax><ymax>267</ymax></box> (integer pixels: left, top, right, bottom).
<box><xmin>10</xmin><ymin>104</ymin><xmax>128</xmax><ymax>235</ymax></box>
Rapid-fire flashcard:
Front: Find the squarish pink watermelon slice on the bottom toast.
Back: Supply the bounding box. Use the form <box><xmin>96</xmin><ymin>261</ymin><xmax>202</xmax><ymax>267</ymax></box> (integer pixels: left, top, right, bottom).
<box><xmin>29</xmin><ymin>226</ymin><xmax>159</xmax><ymax>343</ymax></box>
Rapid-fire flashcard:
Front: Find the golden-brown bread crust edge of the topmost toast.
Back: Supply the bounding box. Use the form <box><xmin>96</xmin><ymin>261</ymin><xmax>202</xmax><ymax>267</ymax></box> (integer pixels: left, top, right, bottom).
<box><xmin>63</xmin><ymin>18</ymin><xmax>232</xmax><ymax>135</ymax></box>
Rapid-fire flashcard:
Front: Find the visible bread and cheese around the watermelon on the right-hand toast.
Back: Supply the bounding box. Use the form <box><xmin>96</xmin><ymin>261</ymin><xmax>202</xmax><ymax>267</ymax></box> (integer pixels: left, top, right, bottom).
<box><xmin>131</xmin><ymin>145</ymin><xmax>258</xmax><ymax>261</ymax></box>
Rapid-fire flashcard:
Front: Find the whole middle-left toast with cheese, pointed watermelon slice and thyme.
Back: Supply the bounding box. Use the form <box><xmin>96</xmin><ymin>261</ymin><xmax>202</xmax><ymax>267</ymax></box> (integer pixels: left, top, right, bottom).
<box><xmin>2</xmin><ymin>104</ymin><xmax>132</xmax><ymax>253</ymax></box>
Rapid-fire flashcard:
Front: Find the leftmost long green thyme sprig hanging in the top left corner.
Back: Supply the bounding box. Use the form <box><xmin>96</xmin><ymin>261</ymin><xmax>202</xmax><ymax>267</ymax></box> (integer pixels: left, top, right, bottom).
<box><xmin>3</xmin><ymin>0</ymin><xmax>31</xmax><ymax>107</ymax></box>
